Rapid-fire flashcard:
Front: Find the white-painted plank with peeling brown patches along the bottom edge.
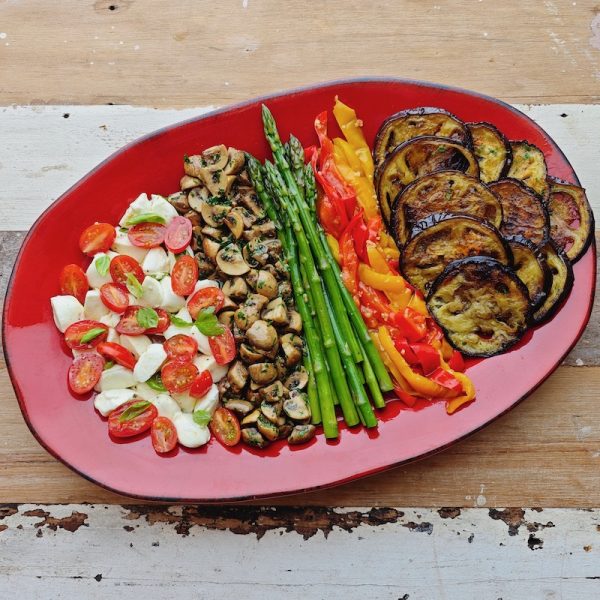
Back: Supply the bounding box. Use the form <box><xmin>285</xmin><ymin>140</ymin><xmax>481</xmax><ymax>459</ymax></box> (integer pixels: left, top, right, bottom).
<box><xmin>0</xmin><ymin>505</ymin><xmax>600</xmax><ymax>600</ymax></box>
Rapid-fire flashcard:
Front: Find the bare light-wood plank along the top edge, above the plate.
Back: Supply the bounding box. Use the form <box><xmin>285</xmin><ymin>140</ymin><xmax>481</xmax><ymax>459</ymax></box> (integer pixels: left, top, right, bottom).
<box><xmin>0</xmin><ymin>0</ymin><xmax>600</xmax><ymax>107</ymax></box>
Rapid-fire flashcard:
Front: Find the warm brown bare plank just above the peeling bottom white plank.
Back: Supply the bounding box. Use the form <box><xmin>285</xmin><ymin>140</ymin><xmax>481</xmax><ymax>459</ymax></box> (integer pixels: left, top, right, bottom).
<box><xmin>0</xmin><ymin>367</ymin><xmax>600</xmax><ymax>507</ymax></box>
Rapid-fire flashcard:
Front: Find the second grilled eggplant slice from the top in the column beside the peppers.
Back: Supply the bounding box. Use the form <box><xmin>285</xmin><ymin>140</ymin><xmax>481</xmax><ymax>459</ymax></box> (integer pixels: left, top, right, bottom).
<box><xmin>377</xmin><ymin>135</ymin><xmax>479</xmax><ymax>223</ymax></box>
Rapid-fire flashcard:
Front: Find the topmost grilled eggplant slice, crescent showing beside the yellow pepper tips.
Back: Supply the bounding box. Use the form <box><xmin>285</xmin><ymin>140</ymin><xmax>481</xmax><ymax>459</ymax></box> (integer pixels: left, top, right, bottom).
<box><xmin>373</xmin><ymin>107</ymin><xmax>471</xmax><ymax>165</ymax></box>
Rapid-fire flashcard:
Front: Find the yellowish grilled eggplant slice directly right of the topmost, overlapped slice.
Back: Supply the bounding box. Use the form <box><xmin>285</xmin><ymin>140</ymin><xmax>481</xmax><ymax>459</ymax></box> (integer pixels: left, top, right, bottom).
<box><xmin>467</xmin><ymin>122</ymin><xmax>512</xmax><ymax>183</ymax></box>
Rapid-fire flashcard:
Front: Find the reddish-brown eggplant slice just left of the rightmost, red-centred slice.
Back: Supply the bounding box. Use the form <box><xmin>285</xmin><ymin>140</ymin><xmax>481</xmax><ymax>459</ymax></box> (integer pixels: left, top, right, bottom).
<box><xmin>489</xmin><ymin>179</ymin><xmax>549</xmax><ymax>247</ymax></box>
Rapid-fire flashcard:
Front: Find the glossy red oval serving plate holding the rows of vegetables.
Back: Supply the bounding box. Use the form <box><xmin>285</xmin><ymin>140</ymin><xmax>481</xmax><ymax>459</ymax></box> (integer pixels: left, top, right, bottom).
<box><xmin>3</xmin><ymin>79</ymin><xmax>596</xmax><ymax>502</ymax></box>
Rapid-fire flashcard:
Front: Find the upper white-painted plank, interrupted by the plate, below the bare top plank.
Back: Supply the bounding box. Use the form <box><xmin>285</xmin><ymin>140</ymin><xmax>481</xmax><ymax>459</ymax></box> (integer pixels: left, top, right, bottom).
<box><xmin>0</xmin><ymin>104</ymin><xmax>600</xmax><ymax>231</ymax></box>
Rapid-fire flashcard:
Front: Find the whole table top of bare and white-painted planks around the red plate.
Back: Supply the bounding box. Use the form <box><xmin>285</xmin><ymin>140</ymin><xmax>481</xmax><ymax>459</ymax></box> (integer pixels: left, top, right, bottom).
<box><xmin>0</xmin><ymin>0</ymin><xmax>600</xmax><ymax>600</ymax></box>
